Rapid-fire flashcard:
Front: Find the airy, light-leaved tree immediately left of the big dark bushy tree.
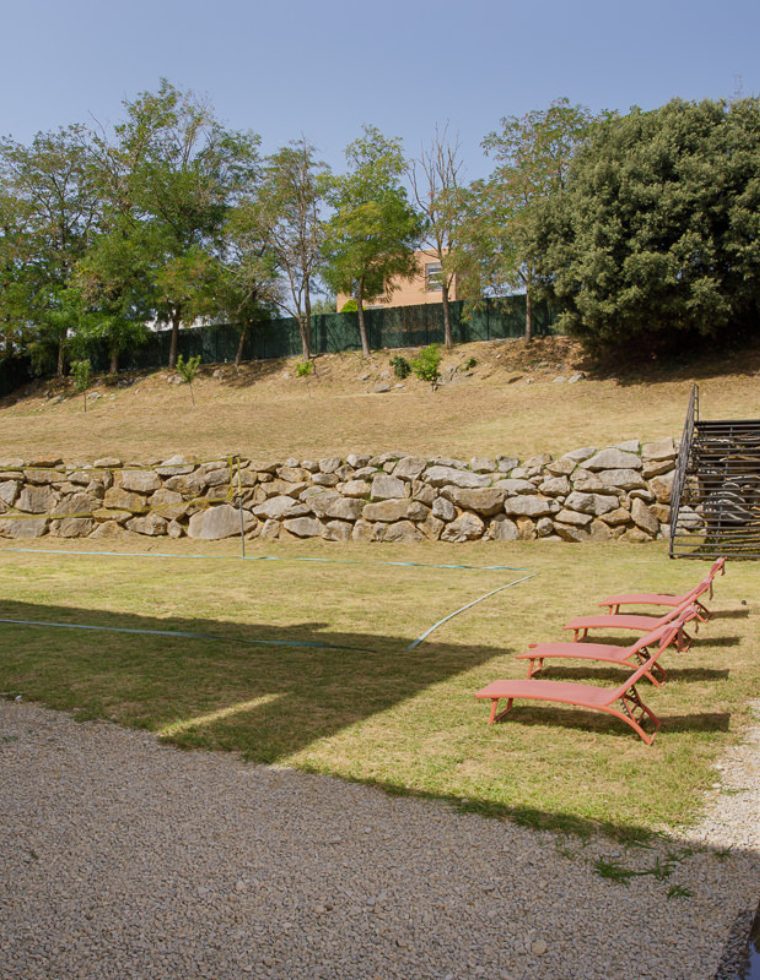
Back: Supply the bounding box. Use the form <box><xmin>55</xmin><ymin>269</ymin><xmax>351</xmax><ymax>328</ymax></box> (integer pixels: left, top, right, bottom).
<box><xmin>478</xmin><ymin>99</ymin><xmax>591</xmax><ymax>340</ymax></box>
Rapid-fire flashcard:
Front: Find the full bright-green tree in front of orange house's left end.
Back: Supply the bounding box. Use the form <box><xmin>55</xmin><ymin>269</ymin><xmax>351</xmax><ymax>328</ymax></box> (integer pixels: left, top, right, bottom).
<box><xmin>324</xmin><ymin>126</ymin><xmax>421</xmax><ymax>357</ymax></box>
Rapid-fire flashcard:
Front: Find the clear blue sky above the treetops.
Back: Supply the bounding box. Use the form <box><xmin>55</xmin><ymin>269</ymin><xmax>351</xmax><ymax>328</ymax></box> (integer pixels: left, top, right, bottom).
<box><xmin>0</xmin><ymin>0</ymin><xmax>760</xmax><ymax>177</ymax></box>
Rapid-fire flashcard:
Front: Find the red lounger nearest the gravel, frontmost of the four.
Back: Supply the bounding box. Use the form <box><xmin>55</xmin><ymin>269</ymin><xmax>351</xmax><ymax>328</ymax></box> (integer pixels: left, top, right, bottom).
<box><xmin>475</xmin><ymin>649</ymin><xmax>662</xmax><ymax>745</ymax></box>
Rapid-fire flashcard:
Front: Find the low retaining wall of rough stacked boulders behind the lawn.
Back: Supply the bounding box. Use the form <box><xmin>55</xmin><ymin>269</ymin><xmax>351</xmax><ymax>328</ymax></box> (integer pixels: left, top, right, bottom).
<box><xmin>0</xmin><ymin>439</ymin><xmax>676</xmax><ymax>542</ymax></box>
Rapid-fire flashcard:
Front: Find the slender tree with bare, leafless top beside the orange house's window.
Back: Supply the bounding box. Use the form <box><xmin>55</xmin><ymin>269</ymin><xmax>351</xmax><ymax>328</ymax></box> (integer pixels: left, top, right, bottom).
<box><xmin>409</xmin><ymin>126</ymin><xmax>468</xmax><ymax>349</ymax></box>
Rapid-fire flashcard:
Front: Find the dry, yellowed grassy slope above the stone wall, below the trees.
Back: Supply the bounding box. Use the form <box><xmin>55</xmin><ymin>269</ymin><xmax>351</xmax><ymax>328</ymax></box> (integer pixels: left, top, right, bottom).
<box><xmin>0</xmin><ymin>338</ymin><xmax>760</xmax><ymax>460</ymax></box>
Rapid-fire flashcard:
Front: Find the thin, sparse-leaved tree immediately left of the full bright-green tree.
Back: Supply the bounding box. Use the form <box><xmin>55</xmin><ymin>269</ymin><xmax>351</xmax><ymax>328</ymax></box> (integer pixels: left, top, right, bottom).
<box><xmin>255</xmin><ymin>137</ymin><xmax>328</xmax><ymax>360</ymax></box>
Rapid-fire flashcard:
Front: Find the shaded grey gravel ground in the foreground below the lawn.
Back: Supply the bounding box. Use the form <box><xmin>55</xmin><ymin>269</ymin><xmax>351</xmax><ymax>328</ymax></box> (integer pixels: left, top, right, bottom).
<box><xmin>0</xmin><ymin>701</ymin><xmax>760</xmax><ymax>980</ymax></box>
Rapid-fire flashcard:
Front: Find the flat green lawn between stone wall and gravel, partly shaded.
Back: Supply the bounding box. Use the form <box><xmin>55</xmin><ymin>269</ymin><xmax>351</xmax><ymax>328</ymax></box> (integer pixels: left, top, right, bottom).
<box><xmin>0</xmin><ymin>540</ymin><xmax>760</xmax><ymax>834</ymax></box>
